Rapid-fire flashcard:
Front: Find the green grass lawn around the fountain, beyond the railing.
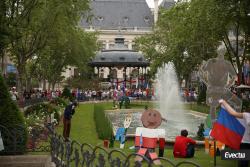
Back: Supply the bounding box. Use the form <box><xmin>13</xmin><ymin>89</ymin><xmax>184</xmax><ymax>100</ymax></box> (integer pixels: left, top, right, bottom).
<box><xmin>57</xmin><ymin>102</ymin><xmax>237</xmax><ymax>167</ymax></box>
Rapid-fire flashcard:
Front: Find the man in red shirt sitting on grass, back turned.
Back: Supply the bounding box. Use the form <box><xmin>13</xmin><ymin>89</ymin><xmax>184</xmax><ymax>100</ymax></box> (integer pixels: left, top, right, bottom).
<box><xmin>173</xmin><ymin>129</ymin><xmax>196</xmax><ymax>158</ymax></box>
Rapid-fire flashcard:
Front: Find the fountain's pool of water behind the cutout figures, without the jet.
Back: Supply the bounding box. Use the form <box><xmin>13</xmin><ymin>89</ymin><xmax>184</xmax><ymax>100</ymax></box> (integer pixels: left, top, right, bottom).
<box><xmin>105</xmin><ymin>109</ymin><xmax>207</xmax><ymax>141</ymax></box>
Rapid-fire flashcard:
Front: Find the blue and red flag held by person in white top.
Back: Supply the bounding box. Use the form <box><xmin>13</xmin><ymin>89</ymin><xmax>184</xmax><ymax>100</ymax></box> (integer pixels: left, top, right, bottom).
<box><xmin>210</xmin><ymin>107</ymin><xmax>245</xmax><ymax>149</ymax></box>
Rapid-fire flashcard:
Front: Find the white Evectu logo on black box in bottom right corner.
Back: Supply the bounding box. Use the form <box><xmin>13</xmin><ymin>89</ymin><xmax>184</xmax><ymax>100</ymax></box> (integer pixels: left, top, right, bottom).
<box><xmin>221</xmin><ymin>150</ymin><xmax>250</xmax><ymax>160</ymax></box>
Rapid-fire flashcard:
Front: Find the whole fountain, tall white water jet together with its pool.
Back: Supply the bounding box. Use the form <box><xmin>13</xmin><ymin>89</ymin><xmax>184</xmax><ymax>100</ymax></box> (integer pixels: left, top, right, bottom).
<box><xmin>107</xmin><ymin>63</ymin><xmax>205</xmax><ymax>140</ymax></box>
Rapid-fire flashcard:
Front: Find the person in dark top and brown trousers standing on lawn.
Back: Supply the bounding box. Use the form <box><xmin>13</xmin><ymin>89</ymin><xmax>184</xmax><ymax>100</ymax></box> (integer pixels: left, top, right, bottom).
<box><xmin>63</xmin><ymin>102</ymin><xmax>77</xmax><ymax>141</ymax></box>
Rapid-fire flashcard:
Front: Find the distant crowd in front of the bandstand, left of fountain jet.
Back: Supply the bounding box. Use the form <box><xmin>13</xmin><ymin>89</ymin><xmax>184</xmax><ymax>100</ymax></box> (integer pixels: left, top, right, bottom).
<box><xmin>10</xmin><ymin>87</ymin><xmax>154</xmax><ymax>101</ymax></box>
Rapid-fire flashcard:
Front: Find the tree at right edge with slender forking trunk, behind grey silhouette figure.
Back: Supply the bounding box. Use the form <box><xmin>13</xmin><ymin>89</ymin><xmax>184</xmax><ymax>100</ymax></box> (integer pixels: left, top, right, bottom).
<box><xmin>211</xmin><ymin>0</ymin><xmax>250</xmax><ymax>84</ymax></box>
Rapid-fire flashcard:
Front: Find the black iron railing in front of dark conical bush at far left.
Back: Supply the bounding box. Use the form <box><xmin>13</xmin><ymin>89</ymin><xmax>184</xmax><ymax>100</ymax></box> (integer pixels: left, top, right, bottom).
<box><xmin>0</xmin><ymin>125</ymin><xmax>51</xmax><ymax>155</ymax></box>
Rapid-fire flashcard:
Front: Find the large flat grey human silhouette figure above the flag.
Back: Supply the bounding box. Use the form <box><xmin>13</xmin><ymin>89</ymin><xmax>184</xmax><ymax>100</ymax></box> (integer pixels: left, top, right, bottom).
<box><xmin>199</xmin><ymin>46</ymin><xmax>241</xmax><ymax>122</ymax></box>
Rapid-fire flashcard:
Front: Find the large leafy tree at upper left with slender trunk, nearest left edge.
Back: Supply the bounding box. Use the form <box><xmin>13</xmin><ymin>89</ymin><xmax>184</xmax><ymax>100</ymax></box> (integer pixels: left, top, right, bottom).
<box><xmin>1</xmin><ymin>0</ymin><xmax>92</xmax><ymax>96</ymax></box>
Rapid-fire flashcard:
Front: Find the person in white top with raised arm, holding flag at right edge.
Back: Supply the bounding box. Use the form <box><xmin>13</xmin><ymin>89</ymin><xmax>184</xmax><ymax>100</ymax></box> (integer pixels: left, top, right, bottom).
<box><xmin>219</xmin><ymin>99</ymin><xmax>250</xmax><ymax>167</ymax></box>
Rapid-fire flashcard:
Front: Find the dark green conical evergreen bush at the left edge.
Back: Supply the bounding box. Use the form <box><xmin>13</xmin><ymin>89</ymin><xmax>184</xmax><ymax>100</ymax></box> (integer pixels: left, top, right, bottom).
<box><xmin>0</xmin><ymin>74</ymin><xmax>28</xmax><ymax>154</ymax></box>
